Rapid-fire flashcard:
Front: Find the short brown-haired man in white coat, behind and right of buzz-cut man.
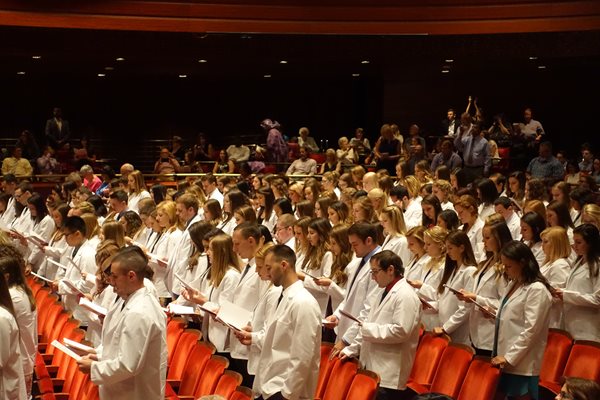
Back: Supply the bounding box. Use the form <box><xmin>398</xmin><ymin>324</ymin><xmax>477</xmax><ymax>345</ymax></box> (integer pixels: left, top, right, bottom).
<box><xmin>165</xmin><ymin>193</ymin><xmax>204</xmax><ymax>298</ymax></box>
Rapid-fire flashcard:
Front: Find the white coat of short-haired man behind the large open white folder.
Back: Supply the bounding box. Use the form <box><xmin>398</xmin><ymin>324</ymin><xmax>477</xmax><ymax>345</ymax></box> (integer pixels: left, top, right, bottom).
<box><xmin>229</xmin><ymin>258</ymin><xmax>270</xmax><ymax>360</ymax></box>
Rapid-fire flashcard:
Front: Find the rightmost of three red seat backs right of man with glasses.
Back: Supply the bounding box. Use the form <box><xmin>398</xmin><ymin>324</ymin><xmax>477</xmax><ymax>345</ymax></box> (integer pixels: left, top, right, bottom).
<box><xmin>456</xmin><ymin>356</ymin><xmax>500</xmax><ymax>400</ymax></box>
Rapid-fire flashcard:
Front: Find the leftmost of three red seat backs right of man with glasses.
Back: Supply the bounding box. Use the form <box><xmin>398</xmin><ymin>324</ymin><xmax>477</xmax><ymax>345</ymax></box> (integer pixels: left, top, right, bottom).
<box><xmin>408</xmin><ymin>332</ymin><xmax>450</xmax><ymax>388</ymax></box>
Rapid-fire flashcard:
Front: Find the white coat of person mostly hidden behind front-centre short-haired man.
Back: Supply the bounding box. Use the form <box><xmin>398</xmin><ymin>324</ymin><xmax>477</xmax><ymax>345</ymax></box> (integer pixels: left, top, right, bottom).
<box><xmin>248</xmin><ymin>282</ymin><xmax>281</xmax><ymax>375</ymax></box>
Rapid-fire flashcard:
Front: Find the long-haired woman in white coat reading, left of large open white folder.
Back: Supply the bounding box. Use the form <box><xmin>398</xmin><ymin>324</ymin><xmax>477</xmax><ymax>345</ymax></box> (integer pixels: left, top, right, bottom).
<box><xmin>181</xmin><ymin>235</ymin><xmax>240</xmax><ymax>353</ymax></box>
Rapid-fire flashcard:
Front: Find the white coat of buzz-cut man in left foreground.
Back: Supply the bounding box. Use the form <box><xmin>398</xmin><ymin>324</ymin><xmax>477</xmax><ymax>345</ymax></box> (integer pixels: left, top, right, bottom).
<box><xmin>90</xmin><ymin>287</ymin><xmax>167</xmax><ymax>400</ymax></box>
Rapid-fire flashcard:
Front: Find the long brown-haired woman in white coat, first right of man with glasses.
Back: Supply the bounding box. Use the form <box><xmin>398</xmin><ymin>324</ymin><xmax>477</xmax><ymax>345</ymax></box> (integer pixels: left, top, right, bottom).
<box><xmin>433</xmin><ymin>231</ymin><xmax>477</xmax><ymax>345</ymax></box>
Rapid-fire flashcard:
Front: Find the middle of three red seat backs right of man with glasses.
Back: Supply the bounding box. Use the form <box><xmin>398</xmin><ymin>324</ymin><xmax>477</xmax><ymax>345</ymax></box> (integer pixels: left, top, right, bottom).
<box><xmin>430</xmin><ymin>343</ymin><xmax>474</xmax><ymax>399</ymax></box>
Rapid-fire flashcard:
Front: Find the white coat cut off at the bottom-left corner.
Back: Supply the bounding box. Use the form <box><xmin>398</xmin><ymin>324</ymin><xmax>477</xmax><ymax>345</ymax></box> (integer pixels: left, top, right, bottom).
<box><xmin>0</xmin><ymin>306</ymin><xmax>26</xmax><ymax>400</ymax></box>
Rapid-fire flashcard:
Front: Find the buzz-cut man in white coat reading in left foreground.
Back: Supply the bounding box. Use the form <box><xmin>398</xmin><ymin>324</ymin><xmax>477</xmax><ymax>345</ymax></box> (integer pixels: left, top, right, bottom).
<box><xmin>78</xmin><ymin>246</ymin><xmax>167</xmax><ymax>400</ymax></box>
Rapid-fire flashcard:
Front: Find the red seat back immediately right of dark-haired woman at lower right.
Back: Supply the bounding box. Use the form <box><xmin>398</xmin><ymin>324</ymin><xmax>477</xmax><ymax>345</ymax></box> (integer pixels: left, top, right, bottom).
<box><xmin>540</xmin><ymin>329</ymin><xmax>573</xmax><ymax>384</ymax></box>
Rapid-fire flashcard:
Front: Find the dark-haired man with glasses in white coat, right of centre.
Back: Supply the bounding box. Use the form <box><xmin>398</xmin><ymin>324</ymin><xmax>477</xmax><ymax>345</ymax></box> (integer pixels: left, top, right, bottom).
<box><xmin>341</xmin><ymin>250</ymin><xmax>421</xmax><ymax>400</ymax></box>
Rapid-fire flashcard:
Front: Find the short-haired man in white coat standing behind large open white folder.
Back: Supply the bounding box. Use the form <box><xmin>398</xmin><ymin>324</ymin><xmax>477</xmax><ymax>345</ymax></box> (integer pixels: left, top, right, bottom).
<box><xmin>225</xmin><ymin>223</ymin><xmax>268</xmax><ymax>387</ymax></box>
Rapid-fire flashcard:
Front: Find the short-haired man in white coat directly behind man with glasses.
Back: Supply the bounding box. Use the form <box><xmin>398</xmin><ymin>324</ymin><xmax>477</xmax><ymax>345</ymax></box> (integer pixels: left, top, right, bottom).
<box><xmin>325</xmin><ymin>222</ymin><xmax>381</xmax><ymax>355</ymax></box>
